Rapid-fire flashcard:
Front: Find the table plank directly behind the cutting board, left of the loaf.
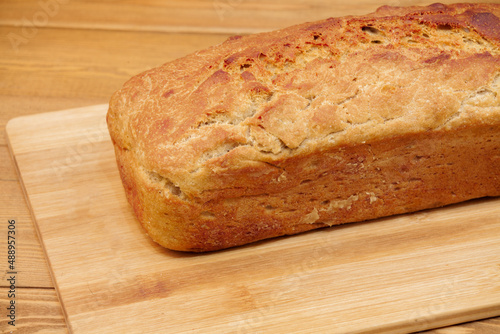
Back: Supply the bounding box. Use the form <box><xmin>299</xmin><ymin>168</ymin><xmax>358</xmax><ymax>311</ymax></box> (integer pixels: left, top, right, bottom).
<box><xmin>0</xmin><ymin>27</ymin><xmax>229</xmax><ymax>145</ymax></box>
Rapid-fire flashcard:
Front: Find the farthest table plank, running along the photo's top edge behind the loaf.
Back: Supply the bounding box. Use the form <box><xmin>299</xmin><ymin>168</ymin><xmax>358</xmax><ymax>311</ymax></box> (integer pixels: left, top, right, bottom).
<box><xmin>0</xmin><ymin>0</ymin><xmax>496</xmax><ymax>34</ymax></box>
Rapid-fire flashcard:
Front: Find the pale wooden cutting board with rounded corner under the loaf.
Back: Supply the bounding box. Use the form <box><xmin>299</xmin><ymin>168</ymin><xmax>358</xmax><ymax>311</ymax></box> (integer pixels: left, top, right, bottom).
<box><xmin>7</xmin><ymin>105</ymin><xmax>500</xmax><ymax>333</ymax></box>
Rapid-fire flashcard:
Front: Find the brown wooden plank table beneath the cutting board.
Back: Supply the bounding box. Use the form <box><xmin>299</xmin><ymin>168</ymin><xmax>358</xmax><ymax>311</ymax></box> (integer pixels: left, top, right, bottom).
<box><xmin>0</xmin><ymin>0</ymin><xmax>500</xmax><ymax>333</ymax></box>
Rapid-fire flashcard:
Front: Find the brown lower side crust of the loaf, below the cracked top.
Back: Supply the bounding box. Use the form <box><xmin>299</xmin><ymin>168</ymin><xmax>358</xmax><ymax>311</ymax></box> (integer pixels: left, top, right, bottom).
<box><xmin>117</xmin><ymin>120</ymin><xmax>500</xmax><ymax>252</ymax></box>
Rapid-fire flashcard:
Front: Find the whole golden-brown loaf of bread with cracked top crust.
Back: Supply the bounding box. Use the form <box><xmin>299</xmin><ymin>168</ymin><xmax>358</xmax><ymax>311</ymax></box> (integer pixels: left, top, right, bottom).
<box><xmin>107</xmin><ymin>4</ymin><xmax>500</xmax><ymax>252</ymax></box>
